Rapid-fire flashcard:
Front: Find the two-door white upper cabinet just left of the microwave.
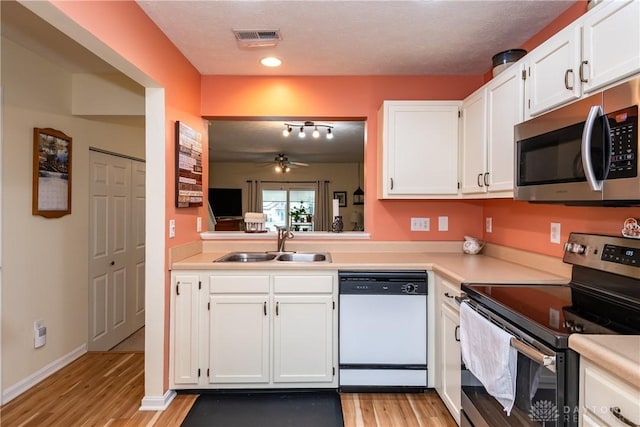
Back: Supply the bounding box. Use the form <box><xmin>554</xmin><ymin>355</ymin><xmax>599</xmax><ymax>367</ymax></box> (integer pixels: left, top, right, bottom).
<box><xmin>461</xmin><ymin>64</ymin><xmax>524</xmax><ymax>197</ymax></box>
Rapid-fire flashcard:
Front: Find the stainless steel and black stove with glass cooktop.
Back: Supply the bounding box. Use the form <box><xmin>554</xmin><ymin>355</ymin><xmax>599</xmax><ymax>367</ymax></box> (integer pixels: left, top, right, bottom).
<box><xmin>461</xmin><ymin>233</ymin><xmax>640</xmax><ymax>427</ymax></box>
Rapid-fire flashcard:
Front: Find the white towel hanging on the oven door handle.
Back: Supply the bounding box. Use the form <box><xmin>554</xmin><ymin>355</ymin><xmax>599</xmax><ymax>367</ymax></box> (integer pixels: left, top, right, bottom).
<box><xmin>460</xmin><ymin>303</ymin><xmax>518</xmax><ymax>415</ymax></box>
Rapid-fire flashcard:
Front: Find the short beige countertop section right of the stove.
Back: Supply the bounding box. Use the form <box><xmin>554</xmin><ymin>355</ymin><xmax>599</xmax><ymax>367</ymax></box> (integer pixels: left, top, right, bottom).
<box><xmin>569</xmin><ymin>334</ymin><xmax>640</xmax><ymax>388</ymax></box>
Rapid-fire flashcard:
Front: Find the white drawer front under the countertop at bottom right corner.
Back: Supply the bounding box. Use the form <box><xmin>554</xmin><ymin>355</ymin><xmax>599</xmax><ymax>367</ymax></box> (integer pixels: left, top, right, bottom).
<box><xmin>581</xmin><ymin>359</ymin><xmax>640</xmax><ymax>426</ymax></box>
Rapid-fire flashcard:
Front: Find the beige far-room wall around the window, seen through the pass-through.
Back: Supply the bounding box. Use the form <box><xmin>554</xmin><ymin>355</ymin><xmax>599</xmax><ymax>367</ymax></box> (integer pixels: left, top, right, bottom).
<box><xmin>209</xmin><ymin>162</ymin><xmax>363</xmax><ymax>230</ymax></box>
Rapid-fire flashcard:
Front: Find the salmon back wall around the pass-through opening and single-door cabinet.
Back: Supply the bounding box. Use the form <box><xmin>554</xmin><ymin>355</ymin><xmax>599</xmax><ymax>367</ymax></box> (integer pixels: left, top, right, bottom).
<box><xmin>202</xmin><ymin>76</ymin><xmax>482</xmax><ymax>240</ymax></box>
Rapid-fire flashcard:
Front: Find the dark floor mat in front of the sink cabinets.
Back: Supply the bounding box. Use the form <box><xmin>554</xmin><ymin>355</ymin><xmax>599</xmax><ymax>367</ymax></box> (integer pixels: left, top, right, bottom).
<box><xmin>182</xmin><ymin>391</ymin><xmax>344</xmax><ymax>427</ymax></box>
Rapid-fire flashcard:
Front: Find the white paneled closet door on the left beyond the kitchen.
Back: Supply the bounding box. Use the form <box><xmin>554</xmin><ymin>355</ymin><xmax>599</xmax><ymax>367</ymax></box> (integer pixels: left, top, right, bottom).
<box><xmin>88</xmin><ymin>151</ymin><xmax>144</xmax><ymax>351</ymax></box>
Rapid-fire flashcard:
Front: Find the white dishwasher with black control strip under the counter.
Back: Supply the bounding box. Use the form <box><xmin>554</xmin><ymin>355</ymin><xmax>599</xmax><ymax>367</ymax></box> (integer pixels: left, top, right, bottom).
<box><xmin>338</xmin><ymin>271</ymin><xmax>428</xmax><ymax>390</ymax></box>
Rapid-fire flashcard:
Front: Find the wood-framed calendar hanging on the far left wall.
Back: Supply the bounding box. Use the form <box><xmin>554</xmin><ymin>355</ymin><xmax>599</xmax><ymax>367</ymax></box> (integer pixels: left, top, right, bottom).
<box><xmin>31</xmin><ymin>128</ymin><xmax>72</xmax><ymax>218</ymax></box>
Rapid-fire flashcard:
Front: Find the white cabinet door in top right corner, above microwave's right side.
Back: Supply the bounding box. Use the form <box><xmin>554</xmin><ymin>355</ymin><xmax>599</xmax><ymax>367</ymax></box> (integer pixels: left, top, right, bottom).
<box><xmin>581</xmin><ymin>0</ymin><xmax>640</xmax><ymax>92</ymax></box>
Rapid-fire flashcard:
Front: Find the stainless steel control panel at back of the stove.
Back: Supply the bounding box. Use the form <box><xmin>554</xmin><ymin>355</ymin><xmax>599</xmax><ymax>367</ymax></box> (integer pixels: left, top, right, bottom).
<box><xmin>562</xmin><ymin>233</ymin><xmax>640</xmax><ymax>279</ymax></box>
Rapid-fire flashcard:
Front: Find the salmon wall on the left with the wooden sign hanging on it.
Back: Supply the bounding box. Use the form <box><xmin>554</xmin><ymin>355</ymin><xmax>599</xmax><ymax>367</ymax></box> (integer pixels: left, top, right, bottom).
<box><xmin>51</xmin><ymin>0</ymin><xmax>208</xmax><ymax>390</ymax></box>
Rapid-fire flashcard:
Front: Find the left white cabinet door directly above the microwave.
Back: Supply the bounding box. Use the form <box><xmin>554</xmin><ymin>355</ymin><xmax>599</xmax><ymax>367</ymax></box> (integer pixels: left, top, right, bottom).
<box><xmin>525</xmin><ymin>25</ymin><xmax>581</xmax><ymax>118</ymax></box>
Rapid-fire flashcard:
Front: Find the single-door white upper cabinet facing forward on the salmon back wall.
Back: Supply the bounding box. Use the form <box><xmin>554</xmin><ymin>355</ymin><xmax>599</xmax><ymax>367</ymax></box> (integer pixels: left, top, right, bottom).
<box><xmin>378</xmin><ymin>101</ymin><xmax>460</xmax><ymax>199</ymax></box>
